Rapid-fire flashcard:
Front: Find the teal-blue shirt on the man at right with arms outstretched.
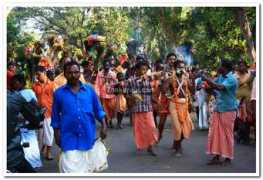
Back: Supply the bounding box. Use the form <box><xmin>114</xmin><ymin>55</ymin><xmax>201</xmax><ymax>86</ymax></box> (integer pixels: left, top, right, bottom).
<box><xmin>214</xmin><ymin>72</ymin><xmax>238</xmax><ymax>112</ymax></box>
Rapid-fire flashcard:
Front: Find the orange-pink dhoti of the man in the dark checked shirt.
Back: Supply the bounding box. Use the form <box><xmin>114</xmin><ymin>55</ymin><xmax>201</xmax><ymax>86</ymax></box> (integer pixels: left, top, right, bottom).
<box><xmin>132</xmin><ymin>112</ymin><xmax>158</xmax><ymax>149</ymax></box>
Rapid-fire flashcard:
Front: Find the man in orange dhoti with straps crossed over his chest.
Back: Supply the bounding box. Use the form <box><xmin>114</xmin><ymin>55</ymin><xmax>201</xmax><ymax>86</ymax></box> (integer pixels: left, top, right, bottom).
<box><xmin>169</xmin><ymin>60</ymin><xmax>193</xmax><ymax>157</ymax></box>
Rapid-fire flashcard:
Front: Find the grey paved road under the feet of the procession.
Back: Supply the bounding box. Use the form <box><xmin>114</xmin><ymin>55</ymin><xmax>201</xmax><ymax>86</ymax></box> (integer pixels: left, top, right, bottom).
<box><xmin>39</xmin><ymin>118</ymin><xmax>256</xmax><ymax>173</ymax></box>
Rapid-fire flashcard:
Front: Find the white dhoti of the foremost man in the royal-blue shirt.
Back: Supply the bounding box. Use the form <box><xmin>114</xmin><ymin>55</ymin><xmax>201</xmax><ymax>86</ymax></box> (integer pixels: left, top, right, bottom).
<box><xmin>59</xmin><ymin>140</ymin><xmax>108</xmax><ymax>173</ymax></box>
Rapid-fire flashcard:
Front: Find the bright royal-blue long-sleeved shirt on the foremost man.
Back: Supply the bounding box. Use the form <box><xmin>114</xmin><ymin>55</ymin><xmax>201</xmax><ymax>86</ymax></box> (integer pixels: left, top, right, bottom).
<box><xmin>51</xmin><ymin>82</ymin><xmax>105</xmax><ymax>151</ymax></box>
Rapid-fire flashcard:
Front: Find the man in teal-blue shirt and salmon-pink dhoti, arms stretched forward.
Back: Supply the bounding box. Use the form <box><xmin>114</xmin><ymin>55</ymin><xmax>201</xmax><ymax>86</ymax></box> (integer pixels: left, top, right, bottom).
<box><xmin>203</xmin><ymin>60</ymin><xmax>238</xmax><ymax>165</ymax></box>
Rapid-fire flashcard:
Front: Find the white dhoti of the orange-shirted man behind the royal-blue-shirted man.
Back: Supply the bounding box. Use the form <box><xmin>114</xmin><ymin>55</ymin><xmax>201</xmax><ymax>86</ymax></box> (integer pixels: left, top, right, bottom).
<box><xmin>40</xmin><ymin>118</ymin><xmax>54</xmax><ymax>146</ymax></box>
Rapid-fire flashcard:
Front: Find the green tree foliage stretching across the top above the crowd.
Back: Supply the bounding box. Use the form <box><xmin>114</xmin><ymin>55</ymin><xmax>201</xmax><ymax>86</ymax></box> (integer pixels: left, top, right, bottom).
<box><xmin>7</xmin><ymin>7</ymin><xmax>256</xmax><ymax>67</ymax></box>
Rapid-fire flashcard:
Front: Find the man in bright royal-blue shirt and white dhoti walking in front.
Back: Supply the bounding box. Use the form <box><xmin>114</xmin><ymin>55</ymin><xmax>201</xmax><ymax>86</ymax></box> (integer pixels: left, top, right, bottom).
<box><xmin>51</xmin><ymin>61</ymin><xmax>106</xmax><ymax>172</ymax></box>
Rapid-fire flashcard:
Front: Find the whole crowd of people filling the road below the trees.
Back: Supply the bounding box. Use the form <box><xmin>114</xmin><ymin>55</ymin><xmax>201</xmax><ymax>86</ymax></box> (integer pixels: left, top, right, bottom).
<box><xmin>7</xmin><ymin>38</ymin><xmax>256</xmax><ymax>172</ymax></box>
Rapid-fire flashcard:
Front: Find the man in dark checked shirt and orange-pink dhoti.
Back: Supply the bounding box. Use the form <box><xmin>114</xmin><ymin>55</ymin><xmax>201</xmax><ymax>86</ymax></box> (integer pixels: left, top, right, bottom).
<box><xmin>128</xmin><ymin>61</ymin><xmax>158</xmax><ymax>156</ymax></box>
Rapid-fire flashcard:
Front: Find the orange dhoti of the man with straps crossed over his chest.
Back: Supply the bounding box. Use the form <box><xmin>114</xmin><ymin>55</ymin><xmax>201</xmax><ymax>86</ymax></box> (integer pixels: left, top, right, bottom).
<box><xmin>169</xmin><ymin>101</ymin><xmax>193</xmax><ymax>141</ymax></box>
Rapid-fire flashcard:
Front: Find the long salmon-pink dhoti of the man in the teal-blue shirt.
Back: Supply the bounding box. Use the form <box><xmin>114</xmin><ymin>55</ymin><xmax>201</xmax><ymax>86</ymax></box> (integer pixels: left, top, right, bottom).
<box><xmin>207</xmin><ymin>111</ymin><xmax>236</xmax><ymax>159</ymax></box>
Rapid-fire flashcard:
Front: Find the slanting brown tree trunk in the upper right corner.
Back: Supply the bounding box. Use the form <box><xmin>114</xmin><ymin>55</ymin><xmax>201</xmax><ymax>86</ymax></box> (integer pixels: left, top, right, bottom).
<box><xmin>234</xmin><ymin>8</ymin><xmax>256</xmax><ymax>63</ymax></box>
